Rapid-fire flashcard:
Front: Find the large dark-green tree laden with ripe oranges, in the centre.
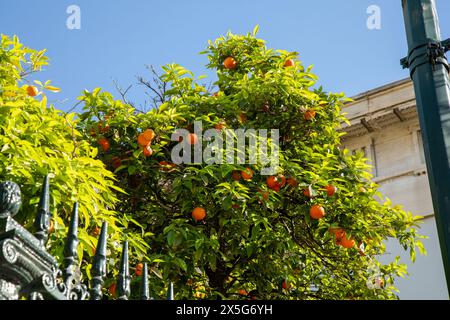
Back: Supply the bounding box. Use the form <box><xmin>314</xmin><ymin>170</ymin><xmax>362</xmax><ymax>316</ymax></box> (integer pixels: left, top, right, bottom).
<box><xmin>79</xmin><ymin>30</ymin><xmax>423</xmax><ymax>299</ymax></box>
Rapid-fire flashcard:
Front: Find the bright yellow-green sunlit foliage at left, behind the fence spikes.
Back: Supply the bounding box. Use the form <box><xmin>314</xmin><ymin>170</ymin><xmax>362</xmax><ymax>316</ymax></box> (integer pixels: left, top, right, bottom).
<box><xmin>0</xmin><ymin>35</ymin><xmax>146</xmax><ymax>284</ymax></box>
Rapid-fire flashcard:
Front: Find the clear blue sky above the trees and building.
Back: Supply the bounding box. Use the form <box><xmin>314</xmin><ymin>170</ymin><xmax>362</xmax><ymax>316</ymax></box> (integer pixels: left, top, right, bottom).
<box><xmin>0</xmin><ymin>0</ymin><xmax>450</xmax><ymax>110</ymax></box>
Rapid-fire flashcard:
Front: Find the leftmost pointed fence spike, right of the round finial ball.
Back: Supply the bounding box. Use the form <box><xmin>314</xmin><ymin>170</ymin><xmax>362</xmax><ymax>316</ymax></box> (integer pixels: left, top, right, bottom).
<box><xmin>34</xmin><ymin>175</ymin><xmax>51</xmax><ymax>247</ymax></box>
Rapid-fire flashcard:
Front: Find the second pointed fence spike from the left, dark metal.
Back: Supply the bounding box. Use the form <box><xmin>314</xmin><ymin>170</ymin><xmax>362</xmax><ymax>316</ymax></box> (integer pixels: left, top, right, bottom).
<box><xmin>64</xmin><ymin>202</ymin><xmax>81</xmax><ymax>291</ymax></box>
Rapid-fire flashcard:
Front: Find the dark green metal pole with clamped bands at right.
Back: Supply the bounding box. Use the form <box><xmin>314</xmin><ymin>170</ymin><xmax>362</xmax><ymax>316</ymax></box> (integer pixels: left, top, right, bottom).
<box><xmin>402</xmin><ymin>0</ymin><xmax>450</xmax><ymax>296</ymax></box>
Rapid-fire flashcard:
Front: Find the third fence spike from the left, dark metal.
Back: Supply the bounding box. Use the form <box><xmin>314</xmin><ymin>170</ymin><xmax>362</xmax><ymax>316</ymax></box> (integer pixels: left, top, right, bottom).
<box><xmin>91</xmin><ymin>221</ymin><xmax>108</xmax><ymax>300</ymax></box>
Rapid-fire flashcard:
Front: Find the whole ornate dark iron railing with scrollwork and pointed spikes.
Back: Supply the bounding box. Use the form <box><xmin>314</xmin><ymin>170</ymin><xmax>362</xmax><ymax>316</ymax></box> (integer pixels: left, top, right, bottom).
<box><xmin>0</xmin><ymin>176</ymin><xmax>174</xmax><ymax>300</ymax></box>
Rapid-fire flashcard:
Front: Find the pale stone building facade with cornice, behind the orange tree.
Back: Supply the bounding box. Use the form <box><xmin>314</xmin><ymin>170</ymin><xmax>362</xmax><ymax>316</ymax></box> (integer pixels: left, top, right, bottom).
<box><xmin>342</xmin><ymin>79</ymin><xmax>449</xmax><ymax>299</ymax></box>
